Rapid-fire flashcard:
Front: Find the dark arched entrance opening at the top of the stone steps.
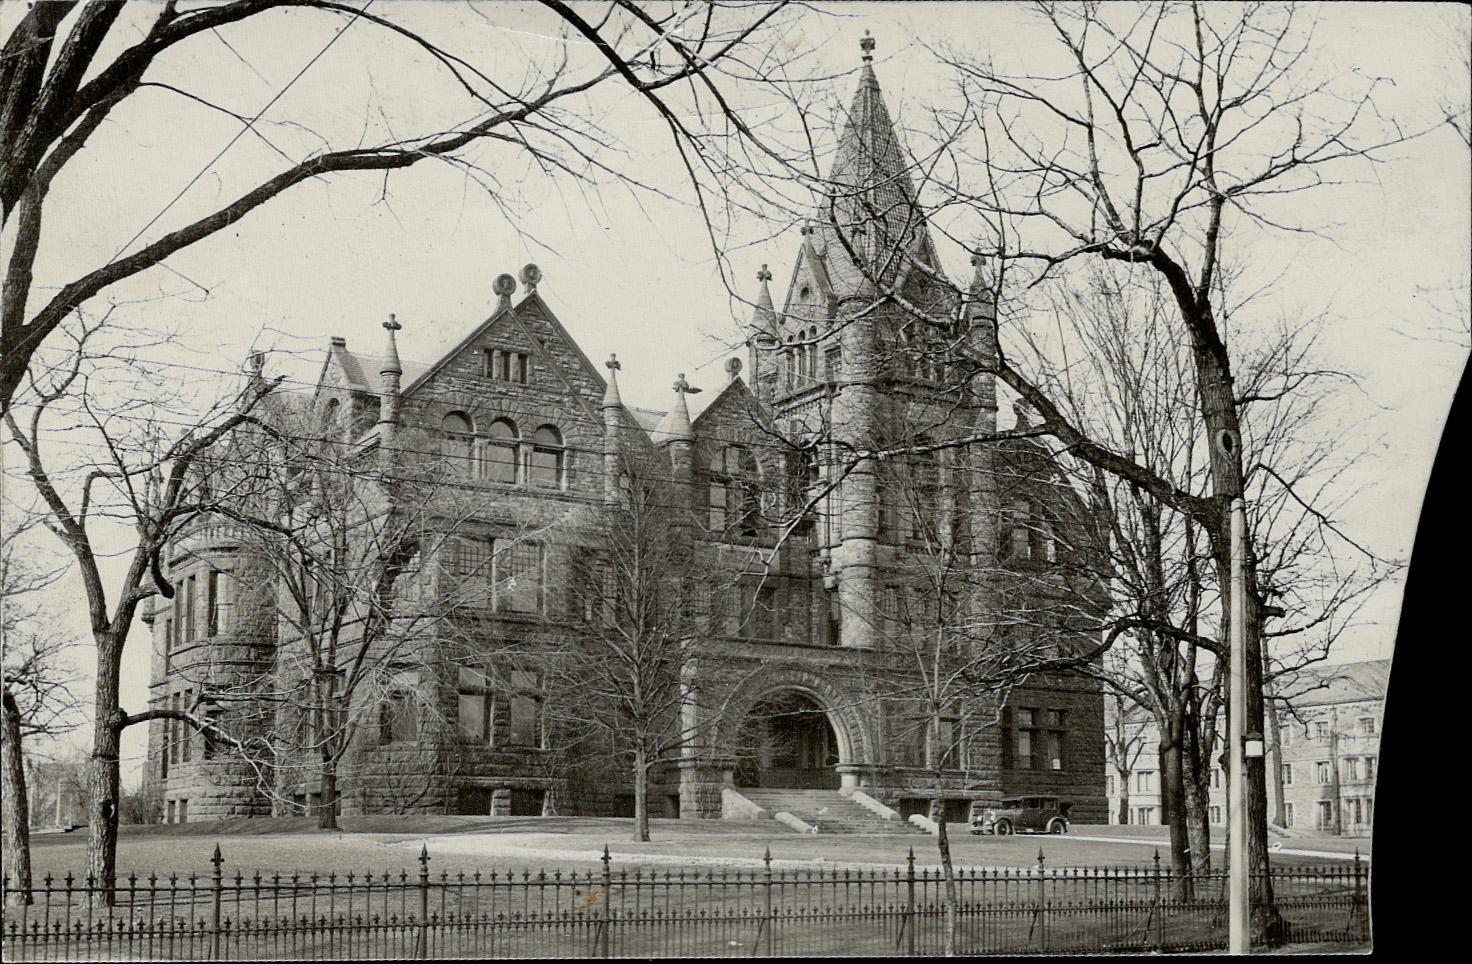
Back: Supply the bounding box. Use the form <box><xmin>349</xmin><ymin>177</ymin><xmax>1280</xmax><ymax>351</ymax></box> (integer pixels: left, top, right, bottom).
<box><xmin>735</xmin><ymin>690</ymin><xmax>841</xmax><ymax>790</ymax></box>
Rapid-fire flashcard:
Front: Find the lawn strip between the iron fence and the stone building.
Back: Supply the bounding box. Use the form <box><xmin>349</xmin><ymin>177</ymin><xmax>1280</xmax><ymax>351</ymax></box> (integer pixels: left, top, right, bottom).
<box><xmin>20</xmin><ymin>817</ymin><xmax>1353</xmax><ymax>879</ymax></box>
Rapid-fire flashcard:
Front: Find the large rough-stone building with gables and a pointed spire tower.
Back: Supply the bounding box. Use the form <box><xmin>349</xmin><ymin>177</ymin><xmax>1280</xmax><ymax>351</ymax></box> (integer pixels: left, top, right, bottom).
<box><xmin>147</xmin><ymin>41</ymin><xmax>1105</xmax><ymax>823</ymax></box>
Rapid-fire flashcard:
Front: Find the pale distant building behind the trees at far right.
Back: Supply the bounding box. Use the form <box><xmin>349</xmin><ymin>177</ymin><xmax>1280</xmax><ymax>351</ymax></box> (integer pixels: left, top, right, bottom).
<box><xmin>1105</xmin><ymin>659</ymin><xmax>1390</xmax><ymax>836</ymax></box>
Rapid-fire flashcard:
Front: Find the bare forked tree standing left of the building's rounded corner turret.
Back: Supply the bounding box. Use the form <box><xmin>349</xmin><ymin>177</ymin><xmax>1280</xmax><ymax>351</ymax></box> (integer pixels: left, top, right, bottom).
<box><xmin>4</xmin><ymin>318</ymin><xmax>272</xmax><ymax>901</ymax></box>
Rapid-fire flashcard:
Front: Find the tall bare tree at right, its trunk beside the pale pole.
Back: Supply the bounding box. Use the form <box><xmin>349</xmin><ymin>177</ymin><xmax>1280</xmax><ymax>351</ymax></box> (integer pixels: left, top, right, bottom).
<box><xmin>759</xmin><ymin>4</ymin><xmax>1412</xmax><ymax>940</ymax></box>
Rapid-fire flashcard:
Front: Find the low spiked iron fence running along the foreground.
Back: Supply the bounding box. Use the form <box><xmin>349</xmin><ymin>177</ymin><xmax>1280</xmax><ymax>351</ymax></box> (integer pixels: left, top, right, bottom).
<box><xmin>0</xmin><ymin>846</ymin><xmax>1369</xmax><ymax>961</ymax></box>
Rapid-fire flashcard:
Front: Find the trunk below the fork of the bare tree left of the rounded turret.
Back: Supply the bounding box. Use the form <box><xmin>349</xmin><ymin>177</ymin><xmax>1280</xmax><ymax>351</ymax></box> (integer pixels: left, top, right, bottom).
<box><xmin>87</xmin><ymin>631</ymin><xmax>124</xmax><ymax>907</ymax></box>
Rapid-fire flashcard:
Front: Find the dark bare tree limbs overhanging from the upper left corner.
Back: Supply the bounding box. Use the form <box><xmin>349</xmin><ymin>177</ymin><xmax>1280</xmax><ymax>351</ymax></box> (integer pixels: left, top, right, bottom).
<box><xmin>0</xmin><ymin>0</ymin><xmax>812</xmax><ymax>408</ymax></box>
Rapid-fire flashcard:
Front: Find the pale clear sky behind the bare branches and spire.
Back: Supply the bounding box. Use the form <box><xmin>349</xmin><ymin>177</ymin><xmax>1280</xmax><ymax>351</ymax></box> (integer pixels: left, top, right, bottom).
<box><xmin>0</xmin><ymin>0</ymin><xmax>1472</xmax><ymax>773</ymax></box>
